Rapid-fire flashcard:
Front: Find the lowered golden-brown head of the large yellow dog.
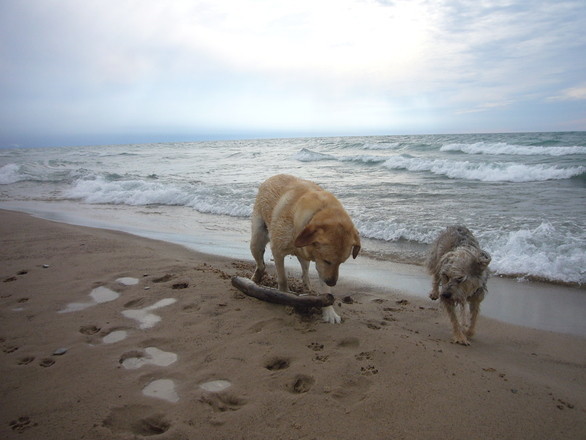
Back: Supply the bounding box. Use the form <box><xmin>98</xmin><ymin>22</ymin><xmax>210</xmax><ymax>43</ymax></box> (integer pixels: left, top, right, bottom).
<box><xmin>295</xmin><ymin>213</ymin><xmax>360</xmax><ymax>286</ymax></box>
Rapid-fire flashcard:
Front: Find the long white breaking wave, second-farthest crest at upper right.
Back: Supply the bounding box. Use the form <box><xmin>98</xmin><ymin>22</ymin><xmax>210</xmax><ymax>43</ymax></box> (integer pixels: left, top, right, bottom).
<box><xmin>384</xmin><ymin>156</ymin><xmax>586</xmax><ymax>182</ymax></box>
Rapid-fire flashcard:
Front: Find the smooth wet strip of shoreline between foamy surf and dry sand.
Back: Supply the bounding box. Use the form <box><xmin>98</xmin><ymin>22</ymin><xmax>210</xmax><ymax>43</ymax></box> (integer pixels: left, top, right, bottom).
<box><xmin>0</xmin><ymin>202</ymin><xmax>586</xmax><ymax>337</ymax></box>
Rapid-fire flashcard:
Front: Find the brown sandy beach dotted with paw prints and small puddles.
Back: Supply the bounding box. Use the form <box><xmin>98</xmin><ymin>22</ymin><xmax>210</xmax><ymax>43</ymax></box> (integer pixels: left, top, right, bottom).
<box><xmin>0</xmin><ymin>211</ymin><xmax>586</xmax><ymax>440</ymax></box>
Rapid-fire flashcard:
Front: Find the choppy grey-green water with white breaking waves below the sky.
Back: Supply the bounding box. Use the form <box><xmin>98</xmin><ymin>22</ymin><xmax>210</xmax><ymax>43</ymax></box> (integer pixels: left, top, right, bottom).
<box><xmin>0</xmin><ymin>132</ymin><xmax>586</xmax><ymax>285</ymax></box>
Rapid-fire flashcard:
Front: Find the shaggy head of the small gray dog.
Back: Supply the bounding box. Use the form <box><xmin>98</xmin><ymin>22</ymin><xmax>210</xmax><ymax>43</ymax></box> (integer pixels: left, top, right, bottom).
<box><xmin>439</xmin><ymin>246</ymin><xmax>491</xmax><ymax>302</ymax></box>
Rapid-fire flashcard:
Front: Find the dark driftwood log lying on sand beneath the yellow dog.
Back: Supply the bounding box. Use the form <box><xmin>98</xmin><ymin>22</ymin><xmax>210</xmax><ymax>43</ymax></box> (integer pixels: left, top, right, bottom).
<box><xmin>232</xmin><ymin>277</ymin><xmax>334</xmax><ymax>307</ymax></box>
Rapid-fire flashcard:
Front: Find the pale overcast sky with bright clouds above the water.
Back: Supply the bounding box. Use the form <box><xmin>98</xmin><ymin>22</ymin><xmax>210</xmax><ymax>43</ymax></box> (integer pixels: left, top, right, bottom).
<box><xmin>0</xmin><ymin>0</ymin><xmax>586</xmax><ymax>146</ymax></box>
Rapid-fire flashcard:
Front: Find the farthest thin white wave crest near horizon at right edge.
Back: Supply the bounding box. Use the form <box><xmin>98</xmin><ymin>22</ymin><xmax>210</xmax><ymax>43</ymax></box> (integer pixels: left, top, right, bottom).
<box><xmin>440</xmin><ymin>142</ymin><xmax>586</xmax><ymax>156</ymax></box>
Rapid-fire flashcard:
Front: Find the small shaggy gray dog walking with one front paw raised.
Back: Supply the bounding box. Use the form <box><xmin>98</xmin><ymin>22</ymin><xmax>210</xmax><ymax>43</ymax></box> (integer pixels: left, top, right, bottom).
<box><xmin>427</xmin><ymin>226</ymin><xmax>491</xmax><ymax>345</ymax></box>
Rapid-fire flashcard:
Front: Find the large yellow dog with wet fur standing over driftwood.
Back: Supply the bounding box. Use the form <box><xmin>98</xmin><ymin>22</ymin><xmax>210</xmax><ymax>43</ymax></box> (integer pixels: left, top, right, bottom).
<box><xmin>250</xmin><ymin>174</ymin><xmax>360</xmax><ymax>323</ymax></box>
